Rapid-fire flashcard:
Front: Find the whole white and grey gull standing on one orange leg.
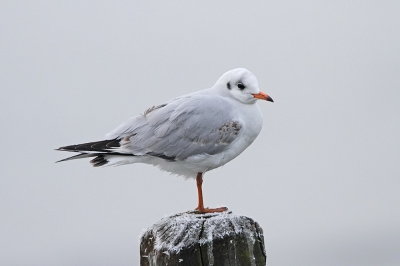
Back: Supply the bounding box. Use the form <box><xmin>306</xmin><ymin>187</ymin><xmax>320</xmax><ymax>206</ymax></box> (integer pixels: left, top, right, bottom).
<box><xmin>57</xmin><ymin>68</ymin><xmax>273</xmax><ymax>213</ymax></box>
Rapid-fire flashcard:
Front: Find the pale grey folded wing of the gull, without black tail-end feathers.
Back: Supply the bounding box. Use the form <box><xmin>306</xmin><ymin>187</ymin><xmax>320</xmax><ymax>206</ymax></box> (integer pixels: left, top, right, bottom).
<box><xmin>109</xmin><ymin>95</ymin><xmax>242</xmax><ymax>160</ymax></box>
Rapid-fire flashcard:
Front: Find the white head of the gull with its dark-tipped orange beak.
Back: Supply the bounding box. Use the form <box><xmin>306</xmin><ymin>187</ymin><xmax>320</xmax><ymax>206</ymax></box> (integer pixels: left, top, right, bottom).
<box><xmin>213</xmin><ymin>68</ymin><xmax>273</xmax><ymax>104</ymax></box>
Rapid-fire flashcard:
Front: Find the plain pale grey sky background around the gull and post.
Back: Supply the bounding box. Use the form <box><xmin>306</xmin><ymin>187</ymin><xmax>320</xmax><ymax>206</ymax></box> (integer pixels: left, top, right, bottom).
<box><xmin>0</xmin><ymin>0</ymin><xmax>400</xmax><ymax>266</ymax></box>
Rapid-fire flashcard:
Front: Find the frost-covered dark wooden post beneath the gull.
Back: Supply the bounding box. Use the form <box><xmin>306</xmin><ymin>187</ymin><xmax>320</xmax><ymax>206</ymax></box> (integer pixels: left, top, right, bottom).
<box><xmin>140</xmin><ymin>212</ymin><xmax>266</xmax><ymax>266</ymax></box>
